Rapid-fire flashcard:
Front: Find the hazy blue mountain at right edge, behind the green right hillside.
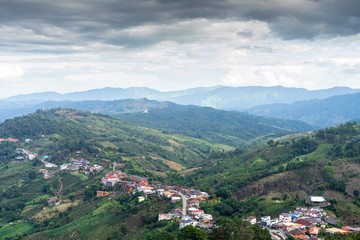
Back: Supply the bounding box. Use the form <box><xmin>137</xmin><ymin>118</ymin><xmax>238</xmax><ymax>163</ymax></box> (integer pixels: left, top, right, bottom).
<box><xmin>248</xmin><ymin>93</ymin><xmax>360</xmax><ymax>127</ymax></box>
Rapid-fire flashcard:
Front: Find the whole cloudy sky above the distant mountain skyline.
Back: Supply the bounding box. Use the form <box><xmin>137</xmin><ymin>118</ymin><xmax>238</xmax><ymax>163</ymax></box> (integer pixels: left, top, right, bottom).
<box><xmin>0</xmin><ymin>0</ymin><xmax>360</xmax><ymax>98</ymax></box>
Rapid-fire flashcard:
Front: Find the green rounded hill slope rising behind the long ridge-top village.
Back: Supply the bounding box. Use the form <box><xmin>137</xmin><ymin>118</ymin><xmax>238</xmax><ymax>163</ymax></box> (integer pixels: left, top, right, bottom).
<box><xmin>0</xmin><ymin>109</ymin><xmax>230</xmax><ymax>171</ymax></box>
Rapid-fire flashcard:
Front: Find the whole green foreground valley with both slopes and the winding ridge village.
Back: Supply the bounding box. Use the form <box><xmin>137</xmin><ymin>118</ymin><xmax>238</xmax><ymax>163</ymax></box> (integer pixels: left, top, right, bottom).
<box><xmin>0</xmin><ymin>108</ymin><xmax>360</xmax><ymax>239</ymax></box>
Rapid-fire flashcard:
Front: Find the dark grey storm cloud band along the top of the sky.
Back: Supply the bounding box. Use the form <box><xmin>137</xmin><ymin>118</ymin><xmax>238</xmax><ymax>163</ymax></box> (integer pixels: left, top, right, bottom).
<box><xmin>0</xmin><ymin>0</ymin><xmax>360</xmax><ymax>49</ymax></box>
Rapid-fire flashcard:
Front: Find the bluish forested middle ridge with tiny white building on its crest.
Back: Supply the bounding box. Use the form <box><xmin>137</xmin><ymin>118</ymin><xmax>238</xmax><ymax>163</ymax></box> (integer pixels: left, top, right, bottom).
<box><xmin>0</xmin><ymin>99</ymin><xmax>312</xmax><ymax>146</ymax></box>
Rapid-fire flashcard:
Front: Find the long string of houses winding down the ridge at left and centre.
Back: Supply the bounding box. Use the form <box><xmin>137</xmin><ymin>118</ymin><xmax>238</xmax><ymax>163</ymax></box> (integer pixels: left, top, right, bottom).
<box><xmin>11</xmin><ymin>143</ymin><xmax>213</xmax><ymax>229</ymax></box>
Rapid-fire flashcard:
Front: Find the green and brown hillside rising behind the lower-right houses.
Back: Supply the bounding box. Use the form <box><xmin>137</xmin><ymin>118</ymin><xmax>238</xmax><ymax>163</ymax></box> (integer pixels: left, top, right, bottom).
<box><xmin>184</xmin><ymin>123</ymin><xmax>360</xmax><ymax>225</ymax></box>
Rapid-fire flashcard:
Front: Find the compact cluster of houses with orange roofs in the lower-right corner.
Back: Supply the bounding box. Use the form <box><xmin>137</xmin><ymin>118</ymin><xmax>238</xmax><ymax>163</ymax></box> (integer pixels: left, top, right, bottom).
<box><xmin>246</xmin><ymin>197</ymin><xmax>360</xmax><ymax>240</ymax></box>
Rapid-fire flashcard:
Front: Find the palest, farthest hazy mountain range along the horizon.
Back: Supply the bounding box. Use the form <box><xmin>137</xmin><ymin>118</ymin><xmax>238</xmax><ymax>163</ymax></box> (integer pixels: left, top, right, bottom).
<box><xmin>5</xmin><ymin>86</ymin><xmax>359</xmax><ymax>110</ymax></box>
